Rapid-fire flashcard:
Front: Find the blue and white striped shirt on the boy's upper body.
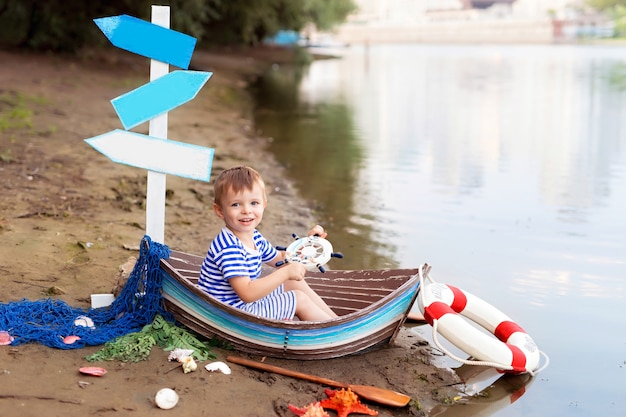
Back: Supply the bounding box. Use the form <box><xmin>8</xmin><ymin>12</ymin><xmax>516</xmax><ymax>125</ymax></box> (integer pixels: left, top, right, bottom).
<box><xmin>198</xmin><ymin>227</ymin><xmax>278</xmax><ymax>308</ymax></box>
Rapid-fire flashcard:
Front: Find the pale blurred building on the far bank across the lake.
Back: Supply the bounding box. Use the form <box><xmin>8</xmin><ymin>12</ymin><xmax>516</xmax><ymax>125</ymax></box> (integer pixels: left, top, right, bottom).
<box><xmin>334</xmin><ymin>0</ymin><xmax>613</xmax><ymax>44</ymax></box>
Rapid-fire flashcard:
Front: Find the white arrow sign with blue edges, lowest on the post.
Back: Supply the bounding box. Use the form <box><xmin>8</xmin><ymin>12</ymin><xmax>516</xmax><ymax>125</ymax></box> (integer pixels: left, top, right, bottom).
<box><xmin>85</xmin><ymin>129</ymin><xmax>214</xmax><ymax>182</ymax></box>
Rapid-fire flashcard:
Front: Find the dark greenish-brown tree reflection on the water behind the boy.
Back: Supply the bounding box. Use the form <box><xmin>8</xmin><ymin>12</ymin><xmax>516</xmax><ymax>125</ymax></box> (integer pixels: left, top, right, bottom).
<box><xmin>249</xmin><ymin>65</ymin><xmax>394</xmax><ymax>269</ymax></box>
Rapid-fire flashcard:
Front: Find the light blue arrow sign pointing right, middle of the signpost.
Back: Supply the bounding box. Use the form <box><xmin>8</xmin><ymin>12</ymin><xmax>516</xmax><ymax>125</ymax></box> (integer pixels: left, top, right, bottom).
<box><xmin>111</xmin><ymin>70</ymin><xmax>213</xmax><ymax>130</ymax></box>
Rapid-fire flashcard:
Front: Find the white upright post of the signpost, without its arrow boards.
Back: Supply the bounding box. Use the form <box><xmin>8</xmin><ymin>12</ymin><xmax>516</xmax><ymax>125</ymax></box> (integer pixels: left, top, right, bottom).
<box><xmin>146</xmin><ymin>5</ymin><xmax>170</xmax><ymax>243</ymax></box>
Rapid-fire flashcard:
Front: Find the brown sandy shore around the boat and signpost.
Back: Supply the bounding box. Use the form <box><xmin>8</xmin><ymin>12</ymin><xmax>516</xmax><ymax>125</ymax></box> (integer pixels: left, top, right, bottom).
<box><xmin>0</xmin><ymin>49</ymin><xmax>459</xmax><ymax>417</ymax></box>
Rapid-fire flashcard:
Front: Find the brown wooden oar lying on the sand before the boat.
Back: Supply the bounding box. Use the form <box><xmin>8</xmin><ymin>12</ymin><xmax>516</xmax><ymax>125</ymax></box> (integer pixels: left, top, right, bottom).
<box><xmin>226</xmin><ymin>356</ymin><xmax>411</xmax><ymax>407</ymax></box>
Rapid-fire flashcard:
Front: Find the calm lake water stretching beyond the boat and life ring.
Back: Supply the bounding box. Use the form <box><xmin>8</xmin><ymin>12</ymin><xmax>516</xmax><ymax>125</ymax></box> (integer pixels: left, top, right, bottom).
<box><xmin>250</xmin><ymin>45</ymin><xmax>626</xmax><ymax>417</ymax></box>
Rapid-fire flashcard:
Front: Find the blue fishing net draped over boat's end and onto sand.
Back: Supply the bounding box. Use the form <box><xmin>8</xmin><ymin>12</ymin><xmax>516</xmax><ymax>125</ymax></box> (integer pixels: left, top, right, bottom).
<box><xmin>0</xmin><ymin>235</ymin><xmax>173</xmax><ymax>349</ymax></box>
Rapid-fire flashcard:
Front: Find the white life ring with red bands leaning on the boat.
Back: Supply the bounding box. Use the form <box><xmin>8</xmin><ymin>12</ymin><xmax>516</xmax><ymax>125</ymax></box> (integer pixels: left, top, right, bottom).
<box><xmin>417</xmin><ymin>265</ymin><xmax>541</xmax><ymax>374</ymax></box>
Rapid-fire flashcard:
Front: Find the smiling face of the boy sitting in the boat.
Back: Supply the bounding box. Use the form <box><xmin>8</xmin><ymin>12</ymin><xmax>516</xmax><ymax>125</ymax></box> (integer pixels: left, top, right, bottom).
<box><xmin>213</xmin><ymin>183</ymin><xmax>267</xmax><ymax>237</ymax></box>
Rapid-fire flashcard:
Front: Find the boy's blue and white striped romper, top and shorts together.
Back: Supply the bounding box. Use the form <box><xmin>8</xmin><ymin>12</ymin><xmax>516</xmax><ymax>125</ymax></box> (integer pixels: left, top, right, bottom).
<box><xmin>198</xmin><ymin>227</ymin><xmax>296</xmax><ymax>320</ymax></box>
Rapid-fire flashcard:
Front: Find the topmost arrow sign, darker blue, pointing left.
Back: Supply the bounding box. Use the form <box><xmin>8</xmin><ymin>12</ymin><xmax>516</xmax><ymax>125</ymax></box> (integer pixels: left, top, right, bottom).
<box><xmin>93</xmin><ymin>14</ymin><xmax>196</xmax><ymax>69</ymax></box>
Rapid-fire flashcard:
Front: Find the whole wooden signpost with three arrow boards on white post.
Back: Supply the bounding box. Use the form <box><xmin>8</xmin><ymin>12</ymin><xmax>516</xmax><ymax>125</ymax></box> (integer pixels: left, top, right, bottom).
<box><xmin>85</xmin><ymin>6</ymin><xmax>214</xmax><ymax>243</ymax></box>
